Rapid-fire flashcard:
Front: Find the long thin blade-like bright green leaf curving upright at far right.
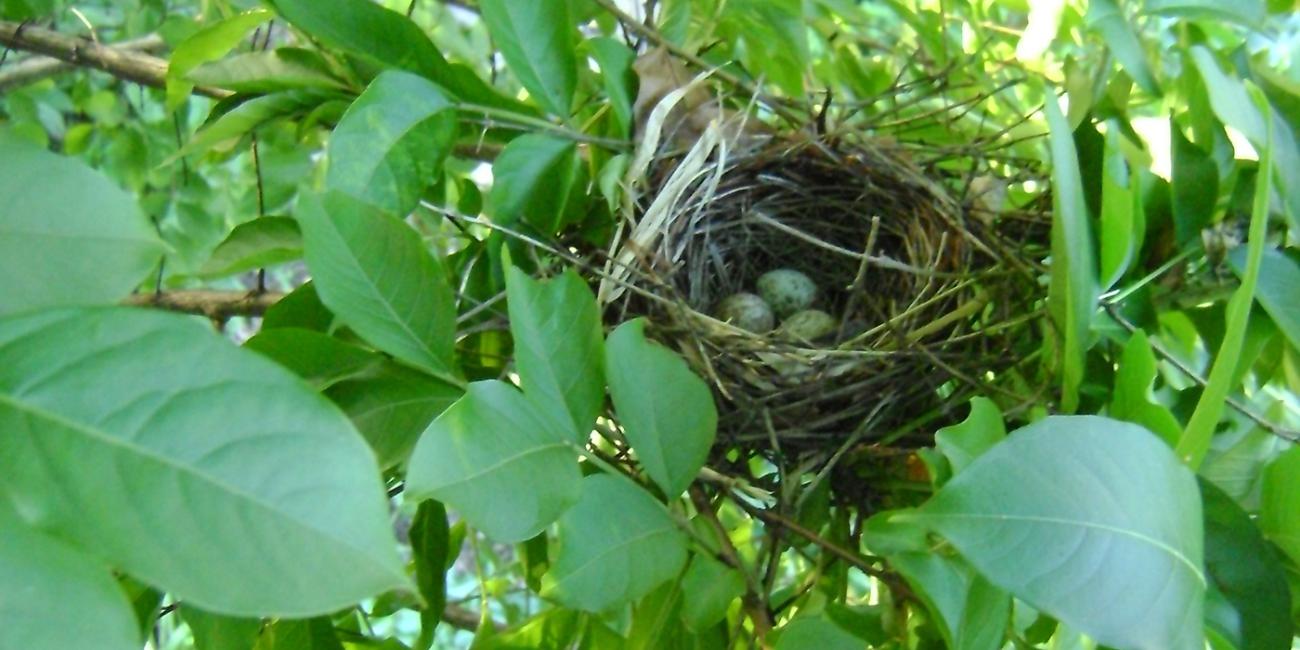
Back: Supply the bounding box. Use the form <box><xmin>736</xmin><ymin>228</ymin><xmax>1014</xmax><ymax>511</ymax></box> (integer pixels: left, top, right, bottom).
<box><xmin>1175</xmin><ymin>86</ymin><xmax>1273</xmax><ymax>469</ymax></box>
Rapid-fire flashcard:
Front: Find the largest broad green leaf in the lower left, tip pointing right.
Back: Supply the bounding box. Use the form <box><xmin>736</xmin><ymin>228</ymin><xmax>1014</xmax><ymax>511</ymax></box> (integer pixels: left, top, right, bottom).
<box><xmin>0</xmin><ymin>307</ymin><xmax>408</xmax><ymax>616</ymax></box>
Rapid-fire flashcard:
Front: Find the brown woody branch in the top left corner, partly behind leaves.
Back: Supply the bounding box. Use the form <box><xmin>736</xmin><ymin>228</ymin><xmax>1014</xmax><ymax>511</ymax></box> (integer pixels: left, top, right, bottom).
<box><xmin>0</xmin><ymin>21</ymin><xmax>231</xmax><ymax>99</ymax></box>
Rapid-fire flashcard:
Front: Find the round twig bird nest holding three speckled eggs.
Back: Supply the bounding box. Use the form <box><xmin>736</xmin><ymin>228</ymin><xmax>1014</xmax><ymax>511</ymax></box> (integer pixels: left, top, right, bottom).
<box><xmin>601</xmin><ymin>120</ymin><xmax>1047</xmax><ymax>460</ymax></box>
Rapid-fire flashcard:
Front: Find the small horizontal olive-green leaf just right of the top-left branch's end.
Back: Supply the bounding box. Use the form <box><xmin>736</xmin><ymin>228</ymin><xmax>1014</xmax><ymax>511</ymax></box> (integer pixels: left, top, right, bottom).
<box><xmin>186</xmin><ymin>48</ymin><xmax>347</xmax><ymax>92</ymax></box>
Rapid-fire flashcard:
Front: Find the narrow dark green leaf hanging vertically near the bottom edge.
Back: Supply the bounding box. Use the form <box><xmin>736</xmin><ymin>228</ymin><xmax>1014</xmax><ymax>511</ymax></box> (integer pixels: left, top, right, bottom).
<box><xmin>411</xmin><ymin>499</ymin><xmax>452</xmax><ymax>650</ymax></box>
